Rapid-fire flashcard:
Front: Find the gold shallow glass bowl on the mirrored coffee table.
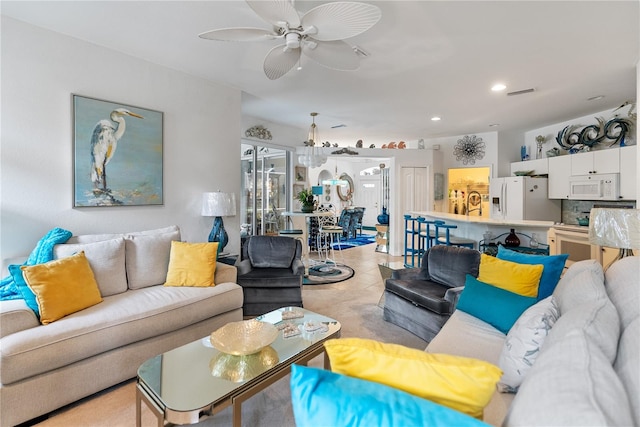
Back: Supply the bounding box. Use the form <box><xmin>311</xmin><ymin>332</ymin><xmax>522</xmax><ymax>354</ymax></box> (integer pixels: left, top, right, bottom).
<box><xmin>209</xmin><ymin>319</ymin><xmax>279</xmax><ymax>356</ymax></box>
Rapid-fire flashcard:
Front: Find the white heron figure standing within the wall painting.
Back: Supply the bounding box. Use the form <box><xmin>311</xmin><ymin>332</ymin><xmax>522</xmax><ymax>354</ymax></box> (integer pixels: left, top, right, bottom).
<box><xmin>91</xmin><ymin>108</ymin><xmax>144</xmax><ymax>192</ymax></box>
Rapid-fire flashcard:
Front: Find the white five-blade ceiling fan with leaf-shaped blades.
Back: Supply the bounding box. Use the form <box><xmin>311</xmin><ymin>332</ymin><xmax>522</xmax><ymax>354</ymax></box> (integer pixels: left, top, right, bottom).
<box><xmin>199</xmin><ymin>0</ymin><xmax>382</xmax><ymax>80</ymax></box>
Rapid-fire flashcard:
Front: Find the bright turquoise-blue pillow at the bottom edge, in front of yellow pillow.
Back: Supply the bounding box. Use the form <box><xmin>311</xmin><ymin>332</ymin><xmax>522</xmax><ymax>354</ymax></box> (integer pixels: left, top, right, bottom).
<box><xmin>291</xmin><ymin>365</ymin><xmax>487</xmax><ymax>427</ymax></box>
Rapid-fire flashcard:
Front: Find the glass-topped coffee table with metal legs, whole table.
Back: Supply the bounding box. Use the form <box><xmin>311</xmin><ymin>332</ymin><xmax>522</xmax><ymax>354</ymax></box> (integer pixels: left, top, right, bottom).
<box><xmin>136</xmin><ymin>307</ymin><xmax>341</xmax><ymax>427</ymax></box>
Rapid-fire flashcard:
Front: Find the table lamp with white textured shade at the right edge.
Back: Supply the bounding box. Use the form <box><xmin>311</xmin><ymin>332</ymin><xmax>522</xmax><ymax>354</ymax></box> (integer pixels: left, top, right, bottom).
<box><xmin>589</xmin><ymin>208</ymin><xmax>640</xmax><ymax>270</ymax></box>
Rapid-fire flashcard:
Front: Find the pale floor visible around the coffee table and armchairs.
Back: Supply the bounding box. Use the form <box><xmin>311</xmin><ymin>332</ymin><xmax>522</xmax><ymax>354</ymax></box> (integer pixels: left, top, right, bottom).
<box><xmin>32</xmin><ymin>246</ymin><xmax>427</xmax><ymax>427</ymax></box>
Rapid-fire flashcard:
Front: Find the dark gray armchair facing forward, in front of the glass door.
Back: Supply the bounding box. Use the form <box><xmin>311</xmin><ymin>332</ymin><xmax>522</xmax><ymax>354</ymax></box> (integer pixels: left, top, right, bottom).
<box><xmin>237</xmin><ymin>236</ymin><xmax>304</xmax><ymax>316</ymax></box>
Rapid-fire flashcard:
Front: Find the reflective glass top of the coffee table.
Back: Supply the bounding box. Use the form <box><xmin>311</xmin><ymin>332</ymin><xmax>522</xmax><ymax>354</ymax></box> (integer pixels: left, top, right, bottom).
<box><xmin>138</xmin><ymin>307</ymin><xmax>341</xmax><ymax>412</ymax></box>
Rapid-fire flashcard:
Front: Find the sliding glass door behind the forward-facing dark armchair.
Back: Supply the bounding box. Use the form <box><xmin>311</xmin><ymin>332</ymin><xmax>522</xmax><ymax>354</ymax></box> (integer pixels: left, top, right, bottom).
<box><xmin>240</xmin><ymin>143</ymin><xmax>291</xmax><ymax>237</ymax></box>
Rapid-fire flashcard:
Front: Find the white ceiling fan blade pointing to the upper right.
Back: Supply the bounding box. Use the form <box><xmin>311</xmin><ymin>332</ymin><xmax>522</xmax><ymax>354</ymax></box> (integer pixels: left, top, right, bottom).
<box><xmin>302</xmin><ymin>2</ymin><xmax>382</xmax><ymax>41</ymax></box>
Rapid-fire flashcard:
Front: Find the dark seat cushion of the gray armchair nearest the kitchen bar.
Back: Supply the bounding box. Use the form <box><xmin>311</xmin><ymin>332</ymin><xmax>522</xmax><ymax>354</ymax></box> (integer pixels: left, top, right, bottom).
<box><xmin>385</xmin><ymin>279</ymin><xmax>451</xmax><ymax>314</ymax></box>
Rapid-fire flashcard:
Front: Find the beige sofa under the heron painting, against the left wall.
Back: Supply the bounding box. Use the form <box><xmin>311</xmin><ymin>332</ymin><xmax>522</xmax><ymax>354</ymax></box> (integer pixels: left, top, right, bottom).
<box><xmin>0</xmin><ymin>226</ymin><xmax>243</xmax><ymax>426</ymax></box>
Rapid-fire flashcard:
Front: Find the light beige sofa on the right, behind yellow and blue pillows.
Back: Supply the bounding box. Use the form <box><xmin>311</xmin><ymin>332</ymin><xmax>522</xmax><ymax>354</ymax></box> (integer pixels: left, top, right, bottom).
<box><xmin>427</xmin><ymin>256</ymin><xmax>640</xmax><ymax>426</ymax></box>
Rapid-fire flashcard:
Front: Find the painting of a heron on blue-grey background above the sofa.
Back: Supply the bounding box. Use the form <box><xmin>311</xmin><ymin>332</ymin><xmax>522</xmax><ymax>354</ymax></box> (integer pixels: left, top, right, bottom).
<box><xmin>72</xmin><ymin>95</ymin><xmax>163</xmax><ymax>207</ymax></box>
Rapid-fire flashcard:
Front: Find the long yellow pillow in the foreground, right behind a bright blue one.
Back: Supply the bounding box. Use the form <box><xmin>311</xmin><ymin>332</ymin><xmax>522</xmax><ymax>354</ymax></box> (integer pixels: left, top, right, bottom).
<box><xmin>324</xmin><ymin>338</ymin><xmax>502</xmax><ymax>419</ymax></box>
